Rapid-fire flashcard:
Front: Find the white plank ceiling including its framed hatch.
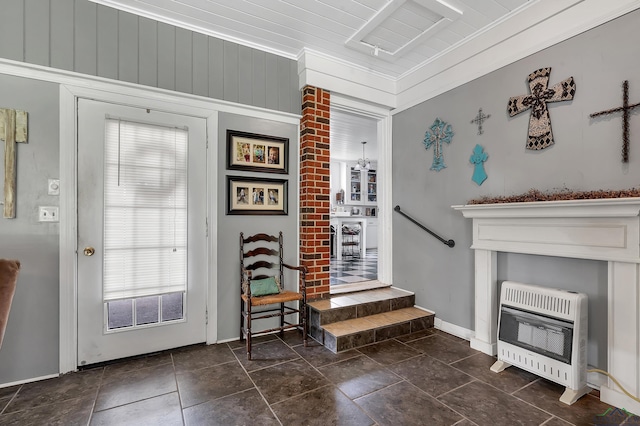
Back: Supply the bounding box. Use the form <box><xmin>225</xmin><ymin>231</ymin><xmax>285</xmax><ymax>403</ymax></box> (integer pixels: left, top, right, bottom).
<box><xmin>92</xmin><ymin>0</ymin><xmax>528</xmax><ymax>78</ymax></box>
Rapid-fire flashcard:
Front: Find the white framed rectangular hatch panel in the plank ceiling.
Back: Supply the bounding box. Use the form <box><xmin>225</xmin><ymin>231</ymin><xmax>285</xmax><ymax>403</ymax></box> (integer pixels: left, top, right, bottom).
<box><xmin>345</xmin><ymin>0</ymin><xmax>462</xmax><ymax>61</ymax></box>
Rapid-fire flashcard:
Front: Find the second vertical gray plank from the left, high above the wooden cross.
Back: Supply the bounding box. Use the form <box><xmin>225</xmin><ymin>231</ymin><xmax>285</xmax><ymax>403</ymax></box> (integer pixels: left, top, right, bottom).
<box><xmin>24</xmin><ymin>0</ymin><xmax>50</xmax><ymax>66</ymax></box>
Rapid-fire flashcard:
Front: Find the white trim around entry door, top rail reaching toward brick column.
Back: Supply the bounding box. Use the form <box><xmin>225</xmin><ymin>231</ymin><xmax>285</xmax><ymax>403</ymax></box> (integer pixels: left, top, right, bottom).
<box><xmin>59</xmin><ymin>79</ymin><xmax>300</xmax><ymax>374</ymax></box>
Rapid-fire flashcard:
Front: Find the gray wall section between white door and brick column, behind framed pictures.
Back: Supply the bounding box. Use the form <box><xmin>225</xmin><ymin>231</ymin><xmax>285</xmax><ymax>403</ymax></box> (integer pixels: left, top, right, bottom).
<box><xmin>218</xmin><ymin>114</ymin><xmax>300</xmax><ymax>340</ymax></box>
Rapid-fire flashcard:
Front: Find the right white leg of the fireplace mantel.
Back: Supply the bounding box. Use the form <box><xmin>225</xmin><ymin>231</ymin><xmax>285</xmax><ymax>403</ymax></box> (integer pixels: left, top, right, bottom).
<box><xmin>600</xmin><ymin>262</ymin><xmax>640</xmax><ymax>414</ymax></box>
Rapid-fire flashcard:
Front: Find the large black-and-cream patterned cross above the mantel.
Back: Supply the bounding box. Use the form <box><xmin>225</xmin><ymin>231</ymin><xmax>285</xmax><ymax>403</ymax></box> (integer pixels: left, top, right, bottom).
<box><xmin>507</xmin><ymin>68</ymin><xmax>576</xmax><ymax>150</ymax></box>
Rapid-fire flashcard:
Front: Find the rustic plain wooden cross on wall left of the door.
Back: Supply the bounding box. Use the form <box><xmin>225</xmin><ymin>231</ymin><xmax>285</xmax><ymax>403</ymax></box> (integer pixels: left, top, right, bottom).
<box><xmin>0</xmin><ymin>108</ymin><xmax>27</xmax><ymax>219</ymax></box>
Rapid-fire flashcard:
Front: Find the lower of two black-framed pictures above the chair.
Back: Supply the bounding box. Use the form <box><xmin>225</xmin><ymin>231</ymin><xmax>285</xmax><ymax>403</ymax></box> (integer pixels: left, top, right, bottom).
<box><xmin>227</xmin><ymin>176</ymin><xmax>289</xmax><ymax>215</ymax></box>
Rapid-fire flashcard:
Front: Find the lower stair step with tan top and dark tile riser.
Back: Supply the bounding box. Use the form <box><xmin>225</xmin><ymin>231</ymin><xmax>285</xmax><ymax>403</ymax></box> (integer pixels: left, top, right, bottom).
<box><xmin>322</xmin><ymin>307</ymin><xmax>435</xmax><ymax>353</ymax></box>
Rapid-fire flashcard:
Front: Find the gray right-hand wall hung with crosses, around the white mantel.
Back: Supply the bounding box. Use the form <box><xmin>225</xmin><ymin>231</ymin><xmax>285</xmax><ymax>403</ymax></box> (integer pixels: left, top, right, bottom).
<box><xmin>393</xmin><ymin>12</ymin><xmax>640</xmax><ymax>366</ymax></box>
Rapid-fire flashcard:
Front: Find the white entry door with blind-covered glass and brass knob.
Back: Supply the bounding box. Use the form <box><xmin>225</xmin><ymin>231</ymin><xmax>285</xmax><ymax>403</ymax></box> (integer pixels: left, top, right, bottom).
<box><xmin>77</xmin><ymin>99</ymin><xmax>207</xmax><ymax>366</ymax></box>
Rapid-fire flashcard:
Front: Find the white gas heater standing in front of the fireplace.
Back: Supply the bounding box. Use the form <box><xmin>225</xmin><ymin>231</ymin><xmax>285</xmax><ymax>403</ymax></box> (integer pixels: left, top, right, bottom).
<box><xmin>491</xmin><ymin>281</ymin><xmax>590</xmax><ymax>405</ymax></box>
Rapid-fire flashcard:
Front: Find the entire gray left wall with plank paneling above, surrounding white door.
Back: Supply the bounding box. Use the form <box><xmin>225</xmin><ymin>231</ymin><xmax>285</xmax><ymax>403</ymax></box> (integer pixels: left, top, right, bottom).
<box><xmin>0</xmin><ymin>0</ymin><xmax>301</xmax><ymax>386</ymax></box>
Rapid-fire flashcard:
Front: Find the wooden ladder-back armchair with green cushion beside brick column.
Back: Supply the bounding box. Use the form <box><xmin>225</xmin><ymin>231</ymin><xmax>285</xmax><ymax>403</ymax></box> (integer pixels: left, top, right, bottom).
<box><xmin>240</xmin><ymin>232</ymin><xmax>307</xmax><ymax>360</ymax></box>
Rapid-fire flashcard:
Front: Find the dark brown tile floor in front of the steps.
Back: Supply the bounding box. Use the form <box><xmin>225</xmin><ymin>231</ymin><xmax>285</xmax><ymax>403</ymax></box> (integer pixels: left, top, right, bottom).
<box><xmin>0</xmin><ymin>329</ymin><xmax>640</xmax><ymax>426</ymax></box>
